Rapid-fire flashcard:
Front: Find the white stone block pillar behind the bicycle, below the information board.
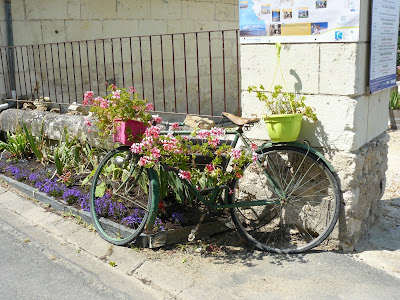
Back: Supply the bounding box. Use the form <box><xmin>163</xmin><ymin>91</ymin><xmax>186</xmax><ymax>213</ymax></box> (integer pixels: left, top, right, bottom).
<box><xmin>241</xmin><ymin>1</ymin><xmax>389</xmax><ymax>251</ymax></box>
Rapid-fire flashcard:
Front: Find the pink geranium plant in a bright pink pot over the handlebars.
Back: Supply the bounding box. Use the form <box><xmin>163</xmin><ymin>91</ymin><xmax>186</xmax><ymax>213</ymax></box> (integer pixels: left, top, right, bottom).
<box><xmin>82</xmin><ymin>84</ymin><xmax>153</xmax><ymax>145</ymax></box>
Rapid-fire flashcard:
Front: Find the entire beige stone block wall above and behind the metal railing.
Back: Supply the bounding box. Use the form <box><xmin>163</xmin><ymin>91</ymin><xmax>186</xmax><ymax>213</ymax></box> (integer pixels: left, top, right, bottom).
<box><xmin>0</xmin><ymin>0</ymin><xmax>238</xmax><ymax>114</ymax></box>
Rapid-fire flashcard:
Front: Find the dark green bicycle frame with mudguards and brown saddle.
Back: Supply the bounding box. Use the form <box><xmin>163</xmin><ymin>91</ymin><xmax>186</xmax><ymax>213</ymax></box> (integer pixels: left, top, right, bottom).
<box><xmin>145</xmin><ymin>123</ymin><xmax>335</xmax><ymax>230</ymax></box>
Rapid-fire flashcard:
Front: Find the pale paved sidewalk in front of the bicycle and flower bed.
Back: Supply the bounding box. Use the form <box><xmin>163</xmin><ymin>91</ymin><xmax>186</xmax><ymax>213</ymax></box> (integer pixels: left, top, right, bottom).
<box><xmin>0</xmin><ymin>183</ymin><xmax>400</xmax><ymax>299</ymax></box>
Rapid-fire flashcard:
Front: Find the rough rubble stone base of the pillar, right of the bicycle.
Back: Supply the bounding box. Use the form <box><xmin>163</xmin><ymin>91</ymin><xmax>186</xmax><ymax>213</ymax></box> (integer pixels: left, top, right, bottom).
<box><xmin>319</xmin><ymin>133</ymin><xmax>389</xmax><ymax>251</ymax></box>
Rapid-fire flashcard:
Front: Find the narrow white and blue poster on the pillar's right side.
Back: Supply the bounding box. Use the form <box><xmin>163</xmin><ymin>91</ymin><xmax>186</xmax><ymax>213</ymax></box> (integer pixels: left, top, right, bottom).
<box><xmin>369</xmin><ymin>0</ymin><xmax>400</xmax><ymax>93</ymax></box>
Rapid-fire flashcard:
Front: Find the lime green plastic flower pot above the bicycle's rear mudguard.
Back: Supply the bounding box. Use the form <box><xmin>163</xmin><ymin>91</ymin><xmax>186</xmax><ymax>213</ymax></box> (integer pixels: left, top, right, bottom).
<box><xmin>263</xmin><ymin>114</ymin><xmax>303</xmax><ymax>143</ymax></box>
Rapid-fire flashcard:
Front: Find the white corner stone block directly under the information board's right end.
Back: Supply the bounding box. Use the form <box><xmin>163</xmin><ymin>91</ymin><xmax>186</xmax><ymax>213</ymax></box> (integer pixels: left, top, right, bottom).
<box><xmin>319</xmin><ymin>43</ymin><xmax>367</xmax><ymax>95</ymax></box>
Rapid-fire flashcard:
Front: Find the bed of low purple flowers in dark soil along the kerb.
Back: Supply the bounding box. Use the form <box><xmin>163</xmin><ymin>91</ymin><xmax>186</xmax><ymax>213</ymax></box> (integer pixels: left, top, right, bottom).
<box><xmin>0</xmin><ymin>153</ymin><xmax>225</xmax><ymax>234</ymax></box>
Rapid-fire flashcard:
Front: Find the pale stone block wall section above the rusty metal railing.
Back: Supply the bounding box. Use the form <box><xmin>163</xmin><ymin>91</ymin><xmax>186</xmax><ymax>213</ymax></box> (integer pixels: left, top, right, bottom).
<box><xmin>7</xmin><ymin>0</ymin><xmax>239</xmax><ymax>45</ymax></box>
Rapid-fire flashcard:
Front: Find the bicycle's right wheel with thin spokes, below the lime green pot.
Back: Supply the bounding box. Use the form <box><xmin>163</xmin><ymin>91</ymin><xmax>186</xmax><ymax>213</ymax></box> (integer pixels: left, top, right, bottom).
<box><xmin>229</xmin><ymin>145</ymin><xmax>341</xmax><ymax>253</ymax></box>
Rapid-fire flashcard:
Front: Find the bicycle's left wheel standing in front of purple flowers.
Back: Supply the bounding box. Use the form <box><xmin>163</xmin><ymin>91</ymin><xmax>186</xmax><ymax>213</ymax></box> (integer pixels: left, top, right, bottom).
<box><xmin>90</xmin><ymin>146</ymin><xmax>154</xmax><ymax>245</ymax></box>
